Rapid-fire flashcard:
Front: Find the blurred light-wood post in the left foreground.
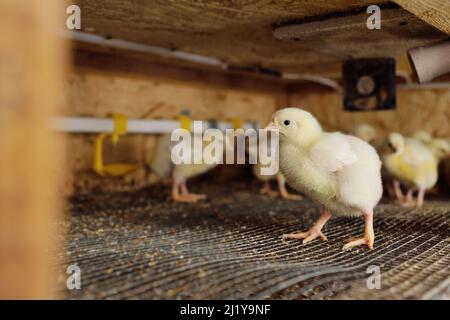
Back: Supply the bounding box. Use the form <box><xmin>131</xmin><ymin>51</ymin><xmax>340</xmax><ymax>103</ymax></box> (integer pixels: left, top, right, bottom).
<box><xmin>0</xmin><ymin>0</ymin><xmax>66</xmax><ymax>299</ymax></box>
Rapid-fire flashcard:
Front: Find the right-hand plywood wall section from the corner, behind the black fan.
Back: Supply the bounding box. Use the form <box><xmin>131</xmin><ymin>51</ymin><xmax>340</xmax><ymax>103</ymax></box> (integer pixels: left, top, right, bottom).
<box><xmin>288</xmin><ymin>88</ymin><xmax>450</xmax><ymax>137</ymax></box>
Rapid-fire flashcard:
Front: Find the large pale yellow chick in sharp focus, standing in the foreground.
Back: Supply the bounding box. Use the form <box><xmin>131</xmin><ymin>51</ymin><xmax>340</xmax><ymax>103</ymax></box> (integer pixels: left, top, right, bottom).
<box><xmin>267</xmin><ymin>108</ymin><xmax>383</xmax><ymax>249</ymax></box>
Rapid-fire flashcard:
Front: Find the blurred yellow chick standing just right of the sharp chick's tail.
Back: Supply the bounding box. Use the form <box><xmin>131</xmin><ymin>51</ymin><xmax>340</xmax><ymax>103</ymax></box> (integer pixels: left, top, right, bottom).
<box><xmin>382</xmin><ymin>133</ymin><xmax>438</xmax><ymax>207</ymax></box>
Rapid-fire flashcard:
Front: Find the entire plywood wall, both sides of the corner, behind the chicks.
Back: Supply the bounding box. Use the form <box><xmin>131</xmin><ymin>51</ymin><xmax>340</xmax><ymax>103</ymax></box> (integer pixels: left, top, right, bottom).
<box><xmin>62</xmin><ymin>49</ymin><xmax>450</xmax><ymax>193</ymax></box>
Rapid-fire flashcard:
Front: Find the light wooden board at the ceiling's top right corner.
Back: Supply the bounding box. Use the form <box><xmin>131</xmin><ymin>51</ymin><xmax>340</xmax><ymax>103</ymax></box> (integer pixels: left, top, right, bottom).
<box><xmin>393</xmin><ymin>0</ymin><xmax>450</xmax><ymax>35</ymax></box>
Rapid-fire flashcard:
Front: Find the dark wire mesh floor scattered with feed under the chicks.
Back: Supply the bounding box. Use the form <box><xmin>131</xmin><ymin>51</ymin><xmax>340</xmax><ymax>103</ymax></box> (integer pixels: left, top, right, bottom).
<box><xmin>55</xmin><ymin>184</ymin><xmax>450</xmax><ymax>299</ymax></box>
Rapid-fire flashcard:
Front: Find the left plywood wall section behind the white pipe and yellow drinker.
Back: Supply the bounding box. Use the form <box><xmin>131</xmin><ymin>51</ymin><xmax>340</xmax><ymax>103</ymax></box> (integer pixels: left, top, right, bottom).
<box><xmin>63</xmin><ymin>53</ymin><xmax>285</xmax><ymax>193</ymax></box>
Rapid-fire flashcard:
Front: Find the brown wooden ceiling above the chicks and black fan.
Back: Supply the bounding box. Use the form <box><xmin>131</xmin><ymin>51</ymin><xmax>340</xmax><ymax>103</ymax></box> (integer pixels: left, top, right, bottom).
<box><xmin>78</xmin><ymin>0</ymin><xmax>448</xmax><ymax>77</ymax></box>
